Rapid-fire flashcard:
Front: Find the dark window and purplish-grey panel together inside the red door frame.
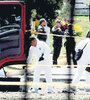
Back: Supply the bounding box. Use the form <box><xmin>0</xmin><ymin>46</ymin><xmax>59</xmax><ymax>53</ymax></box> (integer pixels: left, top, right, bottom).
<box><xmin>0</xmin><ymin>4</ymin><xmax>22</xmax><ymax>60</ymax></box>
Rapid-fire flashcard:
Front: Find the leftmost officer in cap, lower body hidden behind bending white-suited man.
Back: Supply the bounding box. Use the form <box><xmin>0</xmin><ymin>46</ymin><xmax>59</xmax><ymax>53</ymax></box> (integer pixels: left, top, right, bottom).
<box><xmin>37</xmin><ymin>18</ymin><xmax>50</xmax><ymax>42</ymax></box>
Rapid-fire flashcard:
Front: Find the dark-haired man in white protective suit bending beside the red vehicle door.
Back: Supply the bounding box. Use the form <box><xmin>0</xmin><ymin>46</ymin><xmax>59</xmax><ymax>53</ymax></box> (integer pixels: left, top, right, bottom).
<box><xmin>27</xmin><ymin>37</ymin><xmax>53</xmax><ymax>93</ymax></box>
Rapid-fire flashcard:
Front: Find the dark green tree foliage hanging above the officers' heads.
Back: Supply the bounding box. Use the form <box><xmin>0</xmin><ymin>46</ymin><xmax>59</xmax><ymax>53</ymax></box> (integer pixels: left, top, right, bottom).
<box><xmin>26</xmin><ymin>0</ymin><xmax>63</xmax><ymax>26</ymax></box>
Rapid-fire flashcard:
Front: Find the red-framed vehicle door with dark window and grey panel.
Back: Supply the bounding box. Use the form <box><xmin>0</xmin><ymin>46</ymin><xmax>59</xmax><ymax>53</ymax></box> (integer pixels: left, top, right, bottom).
<box><xmin>0</xmin><ymin>0</ymin><xmax>26</xmax><ymax>68</ymax></box>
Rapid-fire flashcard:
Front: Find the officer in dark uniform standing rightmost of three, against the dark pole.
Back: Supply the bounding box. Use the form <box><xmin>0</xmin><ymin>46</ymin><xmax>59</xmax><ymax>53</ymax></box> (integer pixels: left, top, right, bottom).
<box><xmin>65</xmin><ymin>25</ymin><xmax>77</xmax><ymax>65</ymax></box>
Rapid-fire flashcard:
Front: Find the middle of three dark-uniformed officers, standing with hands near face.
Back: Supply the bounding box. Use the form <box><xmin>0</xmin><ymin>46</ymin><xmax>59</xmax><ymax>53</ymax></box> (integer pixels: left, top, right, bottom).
<box><xmin>52</xmin><ymin>21</ymin><xmax>64</xmax><ymax>64</ymax></box>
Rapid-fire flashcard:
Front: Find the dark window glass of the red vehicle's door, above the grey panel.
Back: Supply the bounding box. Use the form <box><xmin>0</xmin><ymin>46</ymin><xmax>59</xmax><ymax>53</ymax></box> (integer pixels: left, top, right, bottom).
<box><xmin>0</xmin><ymin>4</ymin><xmax>21</xmax><ymax>33</ymax></box>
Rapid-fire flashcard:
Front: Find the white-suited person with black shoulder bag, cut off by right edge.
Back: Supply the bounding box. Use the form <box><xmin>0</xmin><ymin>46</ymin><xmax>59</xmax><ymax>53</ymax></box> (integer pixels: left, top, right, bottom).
<box><xmin>72</xmin><ymin>31</ymin><xmax>90</xmax><ymax>91</ymax></box>
